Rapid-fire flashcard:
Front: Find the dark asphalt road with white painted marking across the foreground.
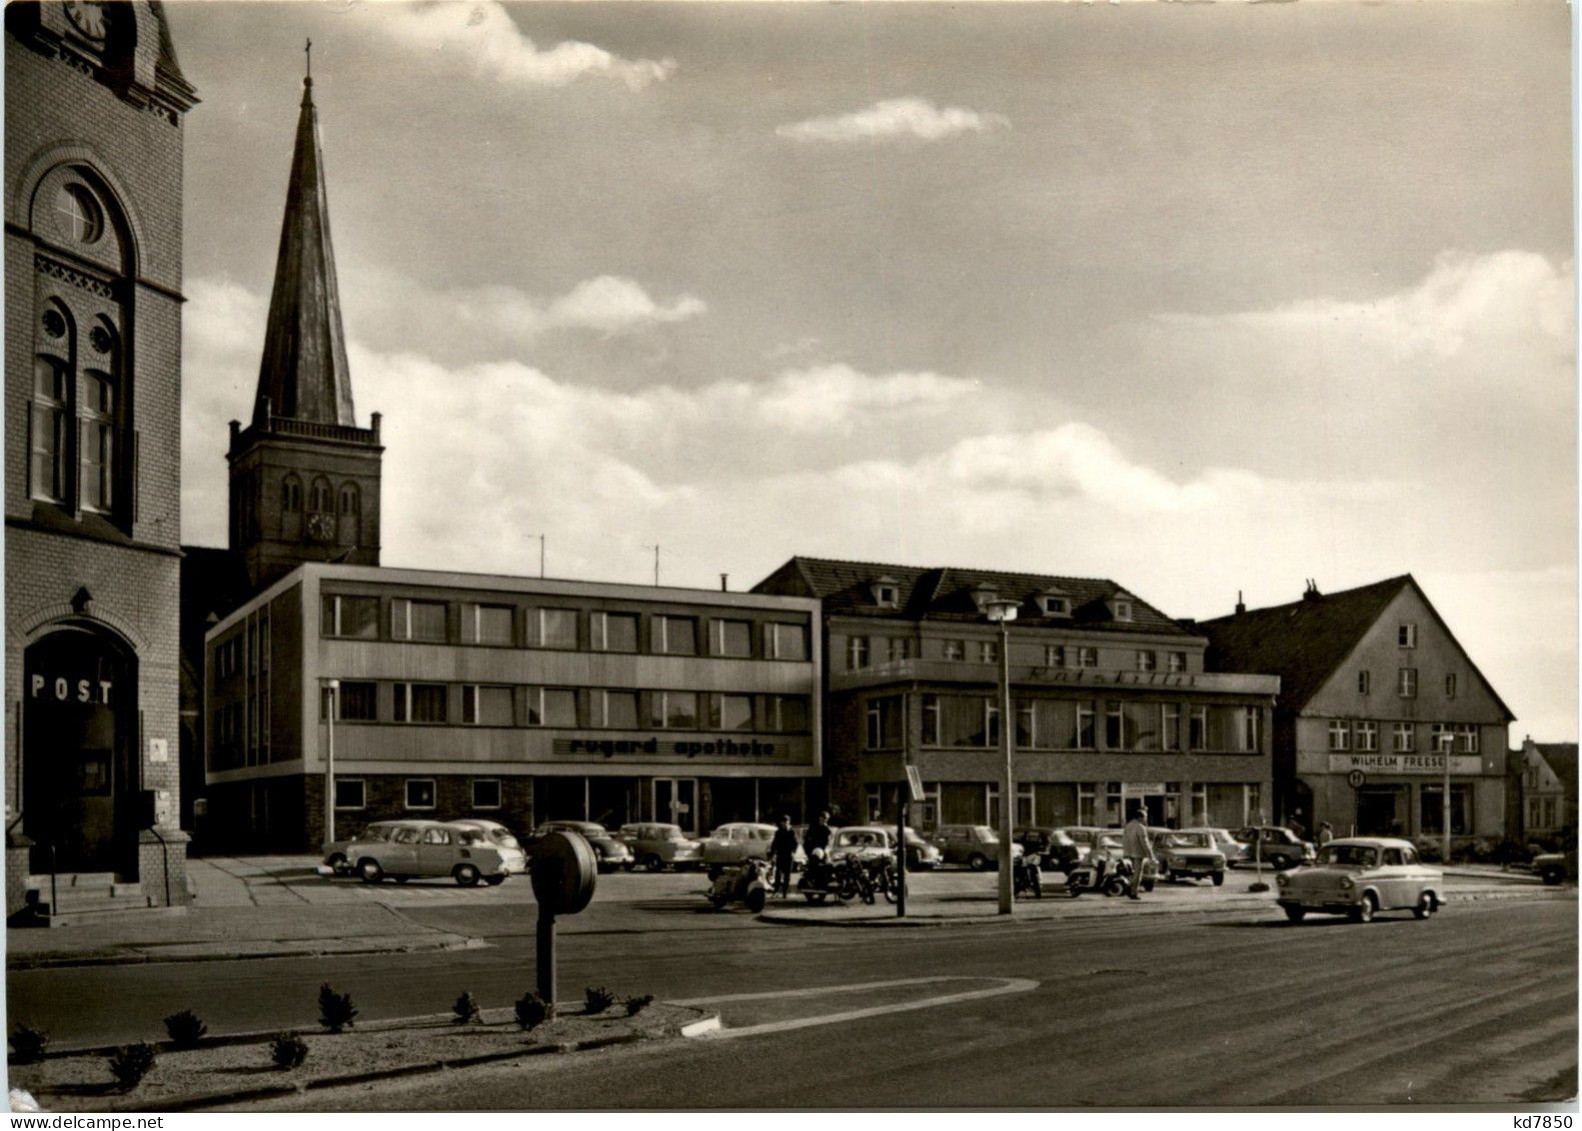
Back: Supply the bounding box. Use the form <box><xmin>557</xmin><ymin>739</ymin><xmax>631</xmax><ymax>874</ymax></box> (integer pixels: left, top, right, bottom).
<box><xmin>9</xmin><ymin>902</ymin><xmax>1577</xmax><ymax>1110</ymax></box>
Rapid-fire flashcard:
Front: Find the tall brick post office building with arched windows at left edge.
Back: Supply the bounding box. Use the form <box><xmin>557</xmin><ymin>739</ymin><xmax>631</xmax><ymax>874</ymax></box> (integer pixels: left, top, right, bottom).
<box><xmin>5</xmin><ymin>0</ymin><xmax>196</xmax><ymax>913</ymax></box>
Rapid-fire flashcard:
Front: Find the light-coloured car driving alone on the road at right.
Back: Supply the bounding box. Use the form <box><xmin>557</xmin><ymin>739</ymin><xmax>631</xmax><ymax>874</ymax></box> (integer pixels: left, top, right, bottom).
<box><xmin>1275</xmin><ymin>837</ymin><xmax>1444</xmax><ymax>922</ymax></box>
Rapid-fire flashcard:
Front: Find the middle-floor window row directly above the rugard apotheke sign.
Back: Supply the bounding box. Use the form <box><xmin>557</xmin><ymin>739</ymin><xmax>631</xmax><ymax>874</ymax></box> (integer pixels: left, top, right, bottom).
<box><xmin>320</xmin><ymin>680</ymin><xmax>808</xmax><ymax>734</ymax></box>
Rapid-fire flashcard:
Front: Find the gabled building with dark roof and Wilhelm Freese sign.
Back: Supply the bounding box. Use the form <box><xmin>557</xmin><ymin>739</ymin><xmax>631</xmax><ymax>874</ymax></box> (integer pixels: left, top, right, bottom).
<box><xmin>1198</xmin><ymin>574</ymin><xmax>1514</xmax><ymax>838</ymax></box>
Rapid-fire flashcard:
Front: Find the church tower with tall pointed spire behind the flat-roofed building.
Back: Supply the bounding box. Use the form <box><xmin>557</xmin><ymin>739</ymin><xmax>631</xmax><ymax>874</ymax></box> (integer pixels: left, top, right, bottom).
<box><xmin>226</xmin><ymin>59</ymin><xmax>384</xmax><ymax>588</ymax></box>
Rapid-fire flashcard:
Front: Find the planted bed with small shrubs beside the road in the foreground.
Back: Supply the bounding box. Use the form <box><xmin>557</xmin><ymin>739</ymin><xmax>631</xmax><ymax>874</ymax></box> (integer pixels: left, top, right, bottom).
<box><xmin>9</xmin><ymin>1003</ymin><xmax>704</xmax><ymax>1112</ymax></box>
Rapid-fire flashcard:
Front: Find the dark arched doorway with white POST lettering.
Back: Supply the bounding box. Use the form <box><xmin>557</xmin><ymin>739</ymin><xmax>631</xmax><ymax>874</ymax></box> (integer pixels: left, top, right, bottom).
<box><xmin>22</xmin><ymin>623</ymin><xmax>141</xmax><ymax>879</ymax></box>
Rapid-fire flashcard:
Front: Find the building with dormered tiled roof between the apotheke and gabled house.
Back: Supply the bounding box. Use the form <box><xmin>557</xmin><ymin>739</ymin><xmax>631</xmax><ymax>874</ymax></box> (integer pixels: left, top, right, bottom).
<box><xmin>755</xmin><ymin>557</ymin><xmax>1278</xmax><ymax>827</ymax></box>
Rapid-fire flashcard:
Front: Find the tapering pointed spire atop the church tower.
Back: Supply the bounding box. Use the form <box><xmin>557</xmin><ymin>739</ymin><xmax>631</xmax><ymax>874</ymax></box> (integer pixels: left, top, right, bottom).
<box><xmin>253</xmin><ymin>48</ymin><xmax>356</xmax><ymax>427</ymax></box>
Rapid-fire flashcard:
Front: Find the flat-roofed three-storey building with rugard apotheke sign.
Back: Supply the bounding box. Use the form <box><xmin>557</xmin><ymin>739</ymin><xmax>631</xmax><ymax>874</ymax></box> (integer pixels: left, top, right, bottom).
<box><xmin>204</xmin><ymin>565</ymin><xmax>823</xmax><ymax>851</ymax></box>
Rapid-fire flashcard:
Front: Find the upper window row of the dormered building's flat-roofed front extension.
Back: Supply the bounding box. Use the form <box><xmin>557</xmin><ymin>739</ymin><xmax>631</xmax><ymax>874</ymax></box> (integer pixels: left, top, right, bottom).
<box><xmin>864</xmin><ymin>694</ymin><xmax>1262</xmax><ymax>753</ymax></box>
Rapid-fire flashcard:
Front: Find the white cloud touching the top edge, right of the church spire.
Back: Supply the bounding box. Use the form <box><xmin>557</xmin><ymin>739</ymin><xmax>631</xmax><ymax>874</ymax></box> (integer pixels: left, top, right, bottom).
<box><xmin>370</xmin><ymin>0</ymin><xmax>676</xmax><ymax>90</ymax></box>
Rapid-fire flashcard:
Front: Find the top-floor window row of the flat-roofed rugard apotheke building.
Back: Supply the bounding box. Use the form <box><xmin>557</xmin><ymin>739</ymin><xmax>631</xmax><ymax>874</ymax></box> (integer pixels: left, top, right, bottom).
<box><xmin>320</xmin><ymin>595</ymin><xmax>810</xmax><ymax>660</ymax></box>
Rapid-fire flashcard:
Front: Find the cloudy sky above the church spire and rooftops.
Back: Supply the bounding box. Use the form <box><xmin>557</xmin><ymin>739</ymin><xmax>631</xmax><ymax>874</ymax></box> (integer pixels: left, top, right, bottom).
<box><xmin>166</xmin><ymin>0</ymin><xmax>1577</xmax><ymax>743</ymax></box>
